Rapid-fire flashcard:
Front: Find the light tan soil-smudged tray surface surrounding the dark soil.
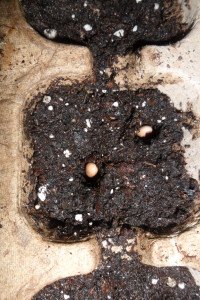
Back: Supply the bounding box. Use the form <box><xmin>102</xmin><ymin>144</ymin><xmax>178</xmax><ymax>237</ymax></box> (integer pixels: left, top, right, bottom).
<box><xmin>0</xmin><ymin>0</ymin><xmax>200</xmax><ymax>300</ymax></box>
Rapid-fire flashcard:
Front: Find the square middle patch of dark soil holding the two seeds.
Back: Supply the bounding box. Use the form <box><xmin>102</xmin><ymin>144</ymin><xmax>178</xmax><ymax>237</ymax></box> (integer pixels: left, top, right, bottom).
<box><xmin>24</xmin><ymin>84</ymin><xmax>198</xmax><ymax>240</ymax></box>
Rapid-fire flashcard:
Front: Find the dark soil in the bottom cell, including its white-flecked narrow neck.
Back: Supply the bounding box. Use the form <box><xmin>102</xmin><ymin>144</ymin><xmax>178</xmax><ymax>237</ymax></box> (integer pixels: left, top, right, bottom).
<box><xmin>33</xmin><ymin>228</ymin><xmax>200</xmax><ymax>300</ymax></box>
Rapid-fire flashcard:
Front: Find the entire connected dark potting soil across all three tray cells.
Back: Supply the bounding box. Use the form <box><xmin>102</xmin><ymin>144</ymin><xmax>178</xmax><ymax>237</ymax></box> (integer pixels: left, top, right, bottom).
<box><xmin>21</xmin><ymin>0</ymin><xmax>200</xmax><ymax>300</ymax></box>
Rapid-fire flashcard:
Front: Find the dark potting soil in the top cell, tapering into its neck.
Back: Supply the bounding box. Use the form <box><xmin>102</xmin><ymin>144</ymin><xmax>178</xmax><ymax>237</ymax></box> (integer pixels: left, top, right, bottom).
<box><xmin>21</xmin><ymin>0</ymin><xmax>191</xmax><ymax>73</ymax></box>
